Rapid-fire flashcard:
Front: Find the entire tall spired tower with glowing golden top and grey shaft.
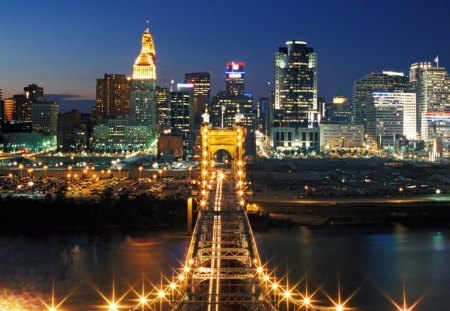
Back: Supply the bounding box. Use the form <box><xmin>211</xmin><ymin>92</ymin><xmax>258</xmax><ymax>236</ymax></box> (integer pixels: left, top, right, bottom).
<box><xmin>130</xmin><ymin>24</ymin><xmax>157</xmax><ymax>150</ymax></box>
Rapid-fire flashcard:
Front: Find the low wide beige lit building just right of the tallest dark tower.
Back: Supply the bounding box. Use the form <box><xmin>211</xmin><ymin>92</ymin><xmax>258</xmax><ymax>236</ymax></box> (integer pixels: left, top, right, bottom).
<box><xmin>320</xmin><ymin>123</ymin><xmax>364</xmax><ymax>149</ymax></box>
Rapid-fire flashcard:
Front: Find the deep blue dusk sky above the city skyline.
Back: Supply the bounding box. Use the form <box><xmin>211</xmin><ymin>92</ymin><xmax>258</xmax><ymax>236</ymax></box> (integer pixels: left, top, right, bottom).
<box><xmin>0</xmin><ymin>0</ymin><xmax>450</xmax><ymax>111</ymax></box>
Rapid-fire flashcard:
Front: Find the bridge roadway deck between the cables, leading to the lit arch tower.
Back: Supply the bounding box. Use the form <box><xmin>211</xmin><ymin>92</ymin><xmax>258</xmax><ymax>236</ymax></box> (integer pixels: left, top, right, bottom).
<box><xmin>173</xmin><ymin>171</ymin><xmax>275</xmax><ymax>311</ymax></box>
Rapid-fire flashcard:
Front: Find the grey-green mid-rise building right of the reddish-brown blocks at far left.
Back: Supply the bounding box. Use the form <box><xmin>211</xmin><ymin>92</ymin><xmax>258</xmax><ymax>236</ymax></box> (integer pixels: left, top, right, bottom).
<box><xmin>31</xmin><ymin>96</ymin><xmax>59</xmax><ymax>146</ymax></box>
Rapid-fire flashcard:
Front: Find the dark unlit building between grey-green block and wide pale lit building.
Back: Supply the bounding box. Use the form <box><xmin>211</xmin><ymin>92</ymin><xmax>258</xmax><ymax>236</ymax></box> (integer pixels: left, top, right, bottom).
<box><xmin>56</xmin><ymin>109</ymin><xmax>81</xmax><ymax>151</ymax></box>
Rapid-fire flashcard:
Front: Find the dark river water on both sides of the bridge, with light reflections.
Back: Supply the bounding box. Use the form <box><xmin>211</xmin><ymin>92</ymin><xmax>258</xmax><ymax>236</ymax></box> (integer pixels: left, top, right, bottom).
<box><xmin>0</xmin><ymin>225</ymin><xmax>450</xmax><ymax>311</ymax></box>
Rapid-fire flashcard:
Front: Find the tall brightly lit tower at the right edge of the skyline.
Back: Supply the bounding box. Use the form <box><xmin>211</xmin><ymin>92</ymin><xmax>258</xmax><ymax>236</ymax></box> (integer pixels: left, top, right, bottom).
<box><xmin>416</xmin><ymin>66</ymin><xmax>450</xmax><ymax>142</ymax></box>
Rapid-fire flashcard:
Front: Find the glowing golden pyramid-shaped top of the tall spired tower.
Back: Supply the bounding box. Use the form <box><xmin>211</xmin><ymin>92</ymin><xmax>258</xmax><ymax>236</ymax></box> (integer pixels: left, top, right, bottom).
<box><xmin>133</xmin><ymin>21</ymin><xmax>156</xmax><ymax>80</ymax></box>
